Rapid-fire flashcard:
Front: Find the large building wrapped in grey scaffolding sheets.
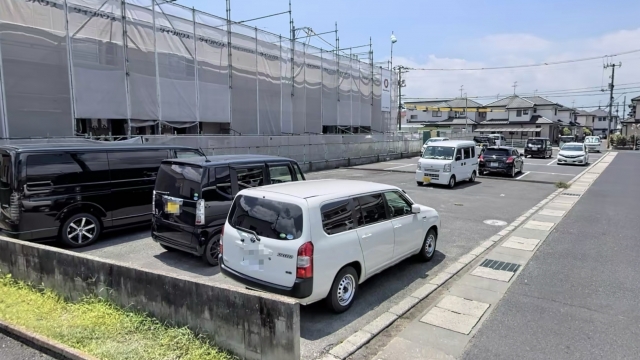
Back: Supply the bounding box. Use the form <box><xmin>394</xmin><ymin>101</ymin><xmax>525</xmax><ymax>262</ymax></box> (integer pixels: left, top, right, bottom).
<box><xmin>0</xmin><ymin>0</ymin><xmax>397</xmax><ymax>138</ymax></box>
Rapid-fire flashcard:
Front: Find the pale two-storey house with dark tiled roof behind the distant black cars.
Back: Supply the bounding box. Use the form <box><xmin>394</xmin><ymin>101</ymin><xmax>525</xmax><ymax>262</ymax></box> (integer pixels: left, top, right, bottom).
<box><xmin>476</xmin><ymin>95</ymin><xmax>573</xmax><ymax>141</ymax></box>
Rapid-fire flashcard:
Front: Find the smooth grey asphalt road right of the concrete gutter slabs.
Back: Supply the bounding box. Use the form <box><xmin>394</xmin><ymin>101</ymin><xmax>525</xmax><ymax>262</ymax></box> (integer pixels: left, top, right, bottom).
<box><xmin>464</xmin><ymin>152</ymin><xmax>640</xmax><ymax>360</ymax></box>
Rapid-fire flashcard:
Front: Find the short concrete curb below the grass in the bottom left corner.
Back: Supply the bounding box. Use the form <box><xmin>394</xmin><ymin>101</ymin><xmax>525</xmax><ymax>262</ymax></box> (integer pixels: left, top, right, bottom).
<box><xmin>0</xmin><ymin>321</ymin><xmax>99</xmax><ymax>360</ymax></box>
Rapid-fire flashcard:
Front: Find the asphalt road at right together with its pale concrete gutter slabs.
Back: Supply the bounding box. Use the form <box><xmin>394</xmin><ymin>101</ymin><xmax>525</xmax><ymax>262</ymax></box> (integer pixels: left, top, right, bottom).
<box><xmin>373</xmin><ymin>153</ymin><xmax>640</xmax><ymax>360</ymax></box>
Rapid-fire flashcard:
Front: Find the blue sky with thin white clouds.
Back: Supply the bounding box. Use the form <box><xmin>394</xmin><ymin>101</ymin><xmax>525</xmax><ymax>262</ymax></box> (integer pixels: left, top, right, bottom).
<box><xmin>178</xmin><ymin>0</ymin><xmax>640</xmax><ymax>112</ymax></box>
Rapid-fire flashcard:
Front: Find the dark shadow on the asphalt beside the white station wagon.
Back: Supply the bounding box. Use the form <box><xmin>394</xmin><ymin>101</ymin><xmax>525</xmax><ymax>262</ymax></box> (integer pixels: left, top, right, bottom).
<box><xmin>300</xmin><ymin>250</ymin><xmax>446</xmax><ymax>340</ymax></box>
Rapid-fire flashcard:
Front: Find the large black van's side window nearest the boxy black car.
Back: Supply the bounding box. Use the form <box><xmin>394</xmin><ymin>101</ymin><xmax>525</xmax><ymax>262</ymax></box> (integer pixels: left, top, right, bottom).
<box><xmin>109</xmin><ymin>150</ymin><xmax>169</xmax><ymax>181</ymax></box>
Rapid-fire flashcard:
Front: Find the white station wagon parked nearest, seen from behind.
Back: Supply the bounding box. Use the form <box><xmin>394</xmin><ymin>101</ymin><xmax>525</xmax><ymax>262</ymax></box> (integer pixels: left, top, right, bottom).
<box><xmin>220</xmin><ymin>180</ymin><xmax>440</xmax><ymax>313</ymax></box>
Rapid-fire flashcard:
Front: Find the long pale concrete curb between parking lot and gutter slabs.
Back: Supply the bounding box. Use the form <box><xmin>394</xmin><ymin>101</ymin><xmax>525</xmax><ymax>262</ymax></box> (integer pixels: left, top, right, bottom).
<box><xmin>321</xmin><ymin>151</ymin><xmax>609</xmax><ymax>360</ymax></box>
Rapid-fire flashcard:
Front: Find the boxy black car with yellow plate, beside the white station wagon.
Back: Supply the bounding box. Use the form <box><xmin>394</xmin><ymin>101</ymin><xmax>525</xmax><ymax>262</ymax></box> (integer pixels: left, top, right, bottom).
<box><xmin>151</xmin><ymin>155</ymin><xmax>305</xmax><ymax>265</ymax></box>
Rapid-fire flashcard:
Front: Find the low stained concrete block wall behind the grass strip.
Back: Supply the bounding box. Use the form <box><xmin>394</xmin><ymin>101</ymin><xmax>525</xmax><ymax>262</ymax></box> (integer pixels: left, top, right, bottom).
<box><xmin>0</xmin><ymin>237</ymin><xmax>300</xmax><ymax>360</ymax></box>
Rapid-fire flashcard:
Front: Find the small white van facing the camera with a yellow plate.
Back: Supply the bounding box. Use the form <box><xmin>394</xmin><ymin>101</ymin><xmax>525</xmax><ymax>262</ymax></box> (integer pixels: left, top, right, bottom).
<box><xmin>416</xmin><ymin>140</ymin><xmax>478</xmax><ymax>188</ymax></box>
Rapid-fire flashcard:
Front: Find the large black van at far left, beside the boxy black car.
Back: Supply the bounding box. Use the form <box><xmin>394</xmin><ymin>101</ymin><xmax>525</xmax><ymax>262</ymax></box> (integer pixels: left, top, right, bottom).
<box><xmin>0</xmin><ymin>143</ymin><xmax>203</xmax><ymax>248</ymax></box>
